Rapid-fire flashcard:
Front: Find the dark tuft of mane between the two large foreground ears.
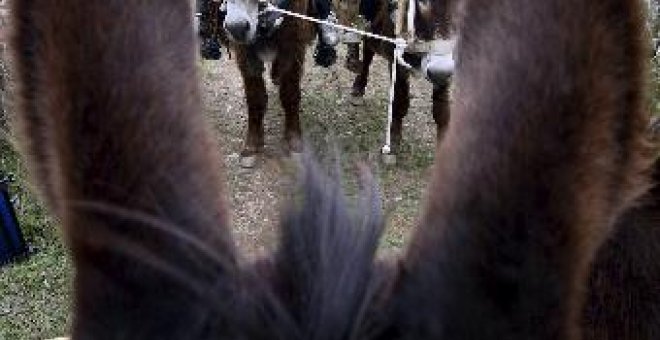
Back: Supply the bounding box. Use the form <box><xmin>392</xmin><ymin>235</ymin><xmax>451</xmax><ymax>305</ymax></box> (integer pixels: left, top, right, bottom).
<box><xmin>264</xmin><ymin>154</ymin><xmax>383</xmax><ymax>339</ymax></box>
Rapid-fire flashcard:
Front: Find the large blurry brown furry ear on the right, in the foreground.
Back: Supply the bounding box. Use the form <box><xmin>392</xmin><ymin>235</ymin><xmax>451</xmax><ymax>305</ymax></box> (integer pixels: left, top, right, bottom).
<box><xmin>395</xmin><ymin>0</ymin><xmax>648</xmax><ymax>339</ymax></box>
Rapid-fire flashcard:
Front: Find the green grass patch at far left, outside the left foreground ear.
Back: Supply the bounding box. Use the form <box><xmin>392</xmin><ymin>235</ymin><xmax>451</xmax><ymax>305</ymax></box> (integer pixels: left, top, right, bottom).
<box><xmin>0</xmin><ymin>138</ymin><xmax>71</xmax><ymax>340</ymax></box>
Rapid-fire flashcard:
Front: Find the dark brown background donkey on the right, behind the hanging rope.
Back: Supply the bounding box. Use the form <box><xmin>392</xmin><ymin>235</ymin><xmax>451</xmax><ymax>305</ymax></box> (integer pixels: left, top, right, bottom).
<box><xmin>351</xmin><ymin>0</ymin><xmax>450</xmax><ymax>162</ymax></box>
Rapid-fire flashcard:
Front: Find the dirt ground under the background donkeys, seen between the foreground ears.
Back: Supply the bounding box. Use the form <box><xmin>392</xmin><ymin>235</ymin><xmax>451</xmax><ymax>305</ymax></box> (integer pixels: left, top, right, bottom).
<box><xmin>201</xmin><ymin>47</ymin><xmax>435</xmax><ymax>254</ymax></box>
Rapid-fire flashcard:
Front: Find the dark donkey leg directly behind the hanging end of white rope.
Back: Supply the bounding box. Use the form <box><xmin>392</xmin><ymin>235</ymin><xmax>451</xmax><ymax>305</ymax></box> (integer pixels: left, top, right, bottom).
<box><xmin>383</xmin><ymin>65</ymin><xmax>410</xmax><ymax>164</ymax></box>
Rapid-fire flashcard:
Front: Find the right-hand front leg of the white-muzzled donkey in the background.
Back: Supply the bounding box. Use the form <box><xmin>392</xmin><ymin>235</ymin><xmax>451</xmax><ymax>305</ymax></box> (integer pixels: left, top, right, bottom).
<box><xmin>280</xmin><ymin>50</ymin><xmax>304</xmax><ymax>155</ymax></box>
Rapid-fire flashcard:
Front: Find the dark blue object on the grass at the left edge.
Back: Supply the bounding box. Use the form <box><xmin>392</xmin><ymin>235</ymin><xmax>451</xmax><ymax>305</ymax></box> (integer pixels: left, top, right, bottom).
<box><xmin>0</xmin><ymin>182</ymin><xmax>28</xmax><ymax>265</ymax></box>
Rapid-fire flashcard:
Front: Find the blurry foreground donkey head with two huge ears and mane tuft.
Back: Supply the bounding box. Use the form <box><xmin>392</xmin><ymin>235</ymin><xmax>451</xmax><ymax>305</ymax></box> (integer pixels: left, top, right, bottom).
<box><xmin>12</xmin><ymin>0</ymin><xmax>660</xmax><ymax>340</ymax></box>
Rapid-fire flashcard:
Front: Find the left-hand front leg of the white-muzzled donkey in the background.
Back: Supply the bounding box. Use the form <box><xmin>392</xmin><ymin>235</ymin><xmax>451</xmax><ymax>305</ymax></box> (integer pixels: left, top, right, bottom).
<box><xmin>237</xmin><ymin>49</ymin><xmax>268</xmax><ymax>168</ymax></box>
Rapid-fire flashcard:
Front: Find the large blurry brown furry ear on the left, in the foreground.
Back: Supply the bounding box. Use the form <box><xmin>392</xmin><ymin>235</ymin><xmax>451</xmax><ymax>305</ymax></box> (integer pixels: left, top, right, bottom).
<box><xmin>12</xmin><ymin>0</ymin><xmax>237</xmax><ymax>339</ymax></box>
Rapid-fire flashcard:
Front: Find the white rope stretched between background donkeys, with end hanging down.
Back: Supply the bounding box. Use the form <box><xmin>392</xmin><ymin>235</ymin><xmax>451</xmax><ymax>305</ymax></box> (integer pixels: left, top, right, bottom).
<box><xmin>260</xmin><ymin>0</ymin><xmax>414</xmax><ymax>155</ymax></box>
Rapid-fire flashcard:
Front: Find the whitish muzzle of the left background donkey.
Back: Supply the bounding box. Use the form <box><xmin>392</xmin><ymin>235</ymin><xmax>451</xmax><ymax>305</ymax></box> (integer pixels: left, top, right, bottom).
<box><xmin>225</xmin><ymin>0</ymin><xmax>259</xmax><ymax>44</ymax></box>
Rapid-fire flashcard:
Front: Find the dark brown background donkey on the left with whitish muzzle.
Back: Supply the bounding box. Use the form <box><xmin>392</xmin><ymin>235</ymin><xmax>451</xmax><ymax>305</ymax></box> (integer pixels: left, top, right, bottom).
<box><xmin>218</xmin><ymin>0</ymin><xmax>315</xmax><ymax>167</ymax></box>
